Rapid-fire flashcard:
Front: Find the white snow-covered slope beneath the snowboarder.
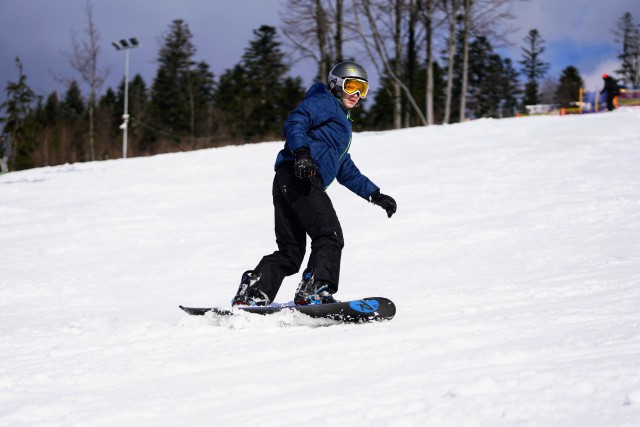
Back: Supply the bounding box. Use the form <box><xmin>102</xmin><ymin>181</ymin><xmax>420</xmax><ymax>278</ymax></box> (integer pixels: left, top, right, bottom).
<box><xmin>0</xmin><ymin>109</ymin><xmax>640</xmax><ymax>427</ymax></box>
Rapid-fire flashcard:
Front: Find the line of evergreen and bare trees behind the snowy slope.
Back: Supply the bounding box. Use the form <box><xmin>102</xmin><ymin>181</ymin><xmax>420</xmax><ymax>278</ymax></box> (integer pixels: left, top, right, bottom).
<box><xmin>1</xmin><ymin>0</ymin><xmax>640</xmax><ymax>170</ymax></box>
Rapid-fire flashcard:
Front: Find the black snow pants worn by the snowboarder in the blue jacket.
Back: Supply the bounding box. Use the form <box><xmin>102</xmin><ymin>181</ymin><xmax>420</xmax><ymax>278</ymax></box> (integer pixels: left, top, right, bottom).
<box><xmin>255</xmin><ymin>162</ymin><xmax>344</xmax><ymax>301</ymax></box>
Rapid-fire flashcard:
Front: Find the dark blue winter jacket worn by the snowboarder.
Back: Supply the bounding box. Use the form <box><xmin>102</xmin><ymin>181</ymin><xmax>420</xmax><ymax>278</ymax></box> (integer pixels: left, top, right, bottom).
<box><xmin>275</xmin><ymin>83</ymin><xmax>378</xmax><ymax>200</ymax></box>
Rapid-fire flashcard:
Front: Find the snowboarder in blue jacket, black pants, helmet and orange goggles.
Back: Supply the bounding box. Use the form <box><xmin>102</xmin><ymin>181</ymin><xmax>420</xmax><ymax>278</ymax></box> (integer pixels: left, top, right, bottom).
<box><xmin>232</xmin><ymin>62</ymin><xmax>396</xmax><ymax>306</ymax></box>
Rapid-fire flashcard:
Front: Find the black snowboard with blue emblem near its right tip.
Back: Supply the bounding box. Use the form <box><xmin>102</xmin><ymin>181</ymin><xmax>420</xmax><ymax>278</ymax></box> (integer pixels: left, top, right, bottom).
<box><xmin>180</xmin><ymin>297</ymin><xmax>396</xmax><ymax>323</ymax></box>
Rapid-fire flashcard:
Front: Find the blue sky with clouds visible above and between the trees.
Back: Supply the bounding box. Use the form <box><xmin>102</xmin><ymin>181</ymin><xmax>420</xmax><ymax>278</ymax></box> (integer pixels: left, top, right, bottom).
<box><xmin>0</xmin><ymin>0</ymin><xmax>640</xmax><ymax>104</ymax></box>
